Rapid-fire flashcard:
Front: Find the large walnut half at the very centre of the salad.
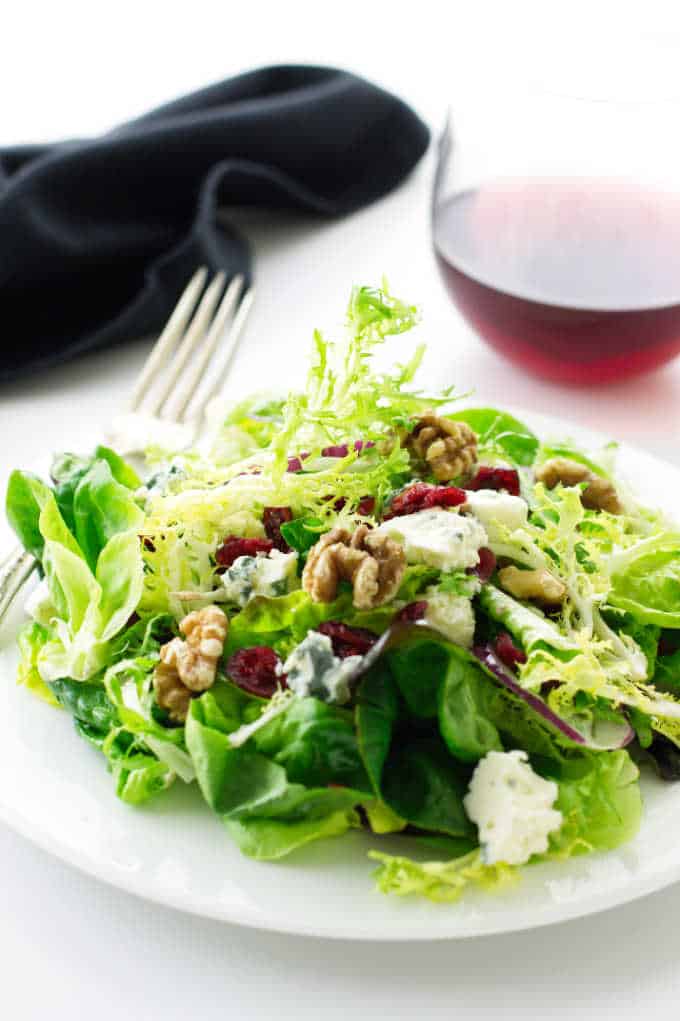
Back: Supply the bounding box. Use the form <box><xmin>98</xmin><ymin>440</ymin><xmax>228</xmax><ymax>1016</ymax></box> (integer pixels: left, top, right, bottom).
<box><xmin>302</xmin><ymin>525</ymin><xmax>406</xmax><ymax>610</ymax></box>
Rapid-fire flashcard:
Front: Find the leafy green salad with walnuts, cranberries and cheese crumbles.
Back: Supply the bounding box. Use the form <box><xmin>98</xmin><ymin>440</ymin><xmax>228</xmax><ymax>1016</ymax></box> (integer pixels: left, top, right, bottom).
<box><xmin>6</xmin><ymin>287</ymin><xmax>680</xmax><ymax>902</ymax></box>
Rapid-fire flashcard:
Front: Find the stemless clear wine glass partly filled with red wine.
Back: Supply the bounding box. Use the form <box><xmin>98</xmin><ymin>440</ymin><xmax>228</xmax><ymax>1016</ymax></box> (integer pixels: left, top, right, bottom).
<box><xmin>432</xmin><ymin>60</ymin><xmax>680</xmax><ymax>384</ymax></box>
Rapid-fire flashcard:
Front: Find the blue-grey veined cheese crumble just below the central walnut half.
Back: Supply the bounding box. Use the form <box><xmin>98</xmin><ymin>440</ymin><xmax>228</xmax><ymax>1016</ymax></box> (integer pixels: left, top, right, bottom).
<box><xmin>279</xmin><ymin>631</ymin><xmax>361</xmax><ymax>706</ymax></box>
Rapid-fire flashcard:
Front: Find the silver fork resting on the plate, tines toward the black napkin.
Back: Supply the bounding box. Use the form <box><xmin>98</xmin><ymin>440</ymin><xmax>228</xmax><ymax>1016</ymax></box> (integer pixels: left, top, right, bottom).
<box><xmin>0</xmin><ymin>266</ymin><xmax>253</xmax><ymax>623</ymax></box>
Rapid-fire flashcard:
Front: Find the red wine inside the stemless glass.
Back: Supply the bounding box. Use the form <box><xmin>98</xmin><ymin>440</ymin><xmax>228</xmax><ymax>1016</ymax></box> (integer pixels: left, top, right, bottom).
<box><xmin>433</xmin><ymin>178</ymin><xmax>680</xmax><ymax>383</ymax></box>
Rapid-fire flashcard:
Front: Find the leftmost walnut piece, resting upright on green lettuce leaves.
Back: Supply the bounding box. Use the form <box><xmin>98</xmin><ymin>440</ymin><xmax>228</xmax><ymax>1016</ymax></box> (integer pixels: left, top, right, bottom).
<box><xmin>153</xmin><ymin>605</ymin><xmax>228</xmax><ymax>723</ymax></box>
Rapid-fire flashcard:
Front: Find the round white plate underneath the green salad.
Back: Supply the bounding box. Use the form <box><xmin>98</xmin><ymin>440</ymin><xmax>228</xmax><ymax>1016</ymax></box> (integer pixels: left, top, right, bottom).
<box><xmin>0</xmin><ymin>410</ymin><xmax>680</xmax><ymax>940</ymax></box>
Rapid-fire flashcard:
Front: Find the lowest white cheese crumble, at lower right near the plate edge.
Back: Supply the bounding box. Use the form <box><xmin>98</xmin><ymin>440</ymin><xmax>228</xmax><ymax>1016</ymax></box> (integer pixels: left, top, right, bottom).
<box><xmin>463</xmin><ymin>750</ymin><xmax>563</xmax><ymax>865</ymax></box>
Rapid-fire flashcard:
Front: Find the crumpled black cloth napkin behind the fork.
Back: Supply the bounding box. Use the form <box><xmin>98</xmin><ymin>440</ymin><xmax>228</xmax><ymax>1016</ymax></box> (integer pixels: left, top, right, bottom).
<box><xmin>0</xmin><ymin>66</ymin><xmax>429</xmax><ymax>380</ymax></box>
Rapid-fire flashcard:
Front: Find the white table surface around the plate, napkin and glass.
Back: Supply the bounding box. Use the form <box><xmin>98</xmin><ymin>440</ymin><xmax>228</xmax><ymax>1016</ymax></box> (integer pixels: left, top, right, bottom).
<box><xmin>0</xmin><ymin>2</ymin><xmax>680</xmax><ymax>1021</ymax></box>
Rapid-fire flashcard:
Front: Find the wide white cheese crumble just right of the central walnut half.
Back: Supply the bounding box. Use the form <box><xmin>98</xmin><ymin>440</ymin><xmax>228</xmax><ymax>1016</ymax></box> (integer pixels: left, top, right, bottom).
<box><xmin>376</xmin><ymin>507</ymin><xmax>488</xmax><ymax>571</ymax></box>
